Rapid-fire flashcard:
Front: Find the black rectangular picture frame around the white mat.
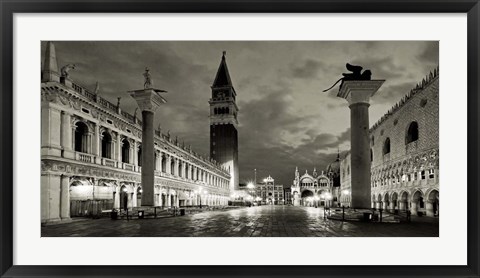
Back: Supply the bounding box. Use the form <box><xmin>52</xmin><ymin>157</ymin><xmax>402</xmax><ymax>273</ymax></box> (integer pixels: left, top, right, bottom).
<box><xmin>0</xmin><ymin>0</ymin><xmax>480</xmax><ymax>277</ymax></box>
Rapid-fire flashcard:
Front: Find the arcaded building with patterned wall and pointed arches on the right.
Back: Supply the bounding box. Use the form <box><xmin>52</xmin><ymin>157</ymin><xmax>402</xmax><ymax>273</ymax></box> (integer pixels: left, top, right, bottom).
<box><xmin>340</xmin><ymin>68</ymin><xmax>439</xmax><ymax>216</ymax></box>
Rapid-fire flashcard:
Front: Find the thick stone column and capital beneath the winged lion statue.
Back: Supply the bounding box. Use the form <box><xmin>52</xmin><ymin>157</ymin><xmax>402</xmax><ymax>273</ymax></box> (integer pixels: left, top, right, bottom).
<box><xmin>337</xmin><ymin>80</ymin><xmax>385</xmax><ymax>208</ymax></box>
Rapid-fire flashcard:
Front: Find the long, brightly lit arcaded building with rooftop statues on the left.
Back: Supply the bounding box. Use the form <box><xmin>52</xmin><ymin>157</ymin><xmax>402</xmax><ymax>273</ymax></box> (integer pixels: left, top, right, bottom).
<box><xmin>41</xmin><ymin>43</ymin><xmax>231</xmax><ymax>223</ymax></box>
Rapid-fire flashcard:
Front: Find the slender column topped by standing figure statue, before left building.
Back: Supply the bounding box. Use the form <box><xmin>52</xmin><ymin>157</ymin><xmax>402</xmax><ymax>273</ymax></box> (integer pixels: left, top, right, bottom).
<box><xmin>129</xmin><ymin>86</ymin><xmax>167</xmax><ymax>207</ymax></box>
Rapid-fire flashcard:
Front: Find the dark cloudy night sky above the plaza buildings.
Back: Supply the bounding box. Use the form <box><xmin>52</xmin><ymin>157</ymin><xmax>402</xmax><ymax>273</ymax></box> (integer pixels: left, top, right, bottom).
<box><xmin>42</xmin><ymin>41</ymin><xmax>438</xmax><ymax>187</ymax></box>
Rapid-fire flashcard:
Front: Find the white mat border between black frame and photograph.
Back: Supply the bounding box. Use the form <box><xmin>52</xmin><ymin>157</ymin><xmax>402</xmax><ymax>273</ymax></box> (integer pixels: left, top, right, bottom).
<box><xmin>14</xmin><ymin>14</ymin><xmax>467</xmax><ymax>265</ymax></box>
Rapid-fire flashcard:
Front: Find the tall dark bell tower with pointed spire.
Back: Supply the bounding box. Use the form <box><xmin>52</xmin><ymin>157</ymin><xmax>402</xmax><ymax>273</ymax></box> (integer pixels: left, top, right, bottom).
<box><xmin>208</xmin><ymin>51</ymin><xmax>239</xmax><ymax>191</ymax></box>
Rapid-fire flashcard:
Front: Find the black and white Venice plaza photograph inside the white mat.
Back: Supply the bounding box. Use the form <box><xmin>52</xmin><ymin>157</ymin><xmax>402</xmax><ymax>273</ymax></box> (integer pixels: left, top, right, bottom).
<box><xmin>40</xmin><ymin>41</ymin><xmax>438</xmax><ymax>237</ymax></box>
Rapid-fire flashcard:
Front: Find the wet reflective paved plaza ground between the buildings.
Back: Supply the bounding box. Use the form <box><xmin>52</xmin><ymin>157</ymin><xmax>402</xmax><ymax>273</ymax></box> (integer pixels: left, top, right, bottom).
<box><xmin>42</xmin><ymin>206</ymin><xmax>439</xmax><ymax>237</ymax></box>
